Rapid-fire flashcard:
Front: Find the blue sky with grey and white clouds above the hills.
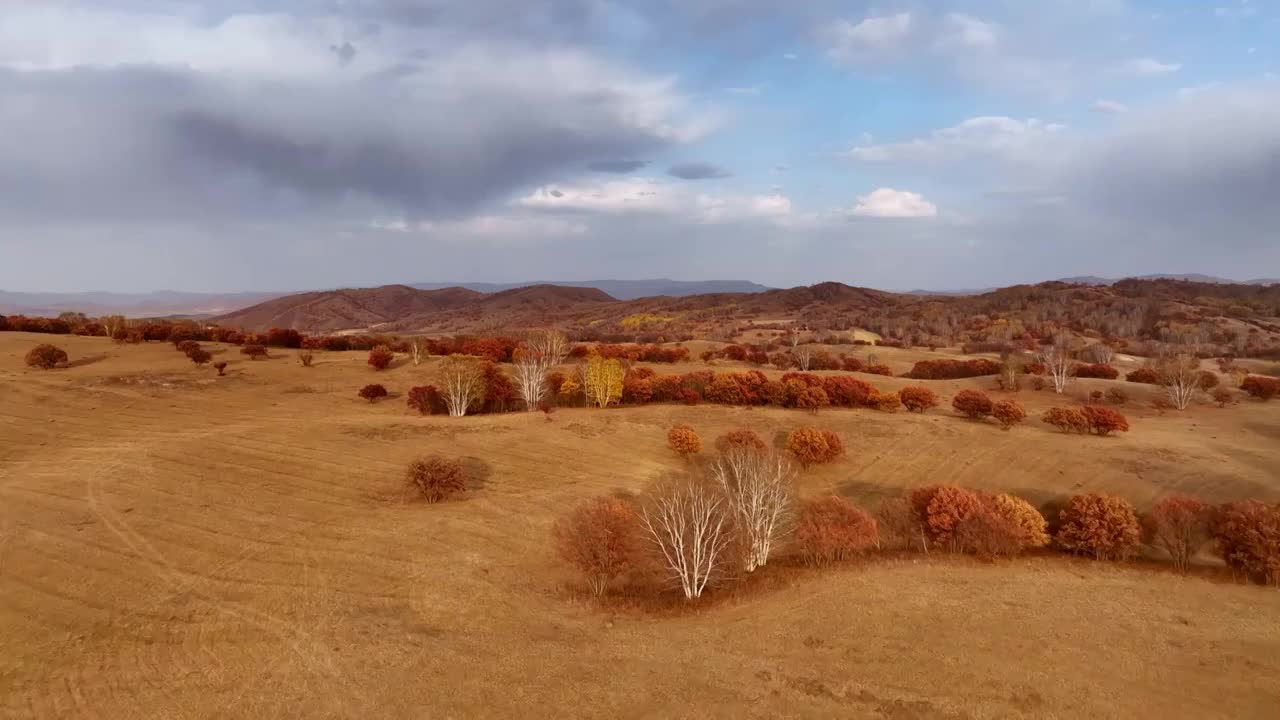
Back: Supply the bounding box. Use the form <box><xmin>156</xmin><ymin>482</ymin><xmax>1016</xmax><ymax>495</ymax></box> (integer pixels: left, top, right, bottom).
<box><xmin>0</xmin><ymin>0</ymin><xmax>1280</xmax><ymax>292</ymax></box>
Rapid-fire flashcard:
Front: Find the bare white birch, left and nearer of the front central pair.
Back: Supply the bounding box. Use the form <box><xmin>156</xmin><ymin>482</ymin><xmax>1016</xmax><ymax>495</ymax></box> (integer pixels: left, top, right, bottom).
<box><xmin>640</xmin><ymin>477</ymin><xmax>733</xmax><ymax>600</ymax></box>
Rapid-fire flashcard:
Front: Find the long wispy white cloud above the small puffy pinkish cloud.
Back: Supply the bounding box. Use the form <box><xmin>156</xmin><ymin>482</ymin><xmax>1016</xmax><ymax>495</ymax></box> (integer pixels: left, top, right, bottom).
<box><xmin>847</xmin><ymin>115</ymin><xmax>1066</xmax><ymax>163</ymax></box>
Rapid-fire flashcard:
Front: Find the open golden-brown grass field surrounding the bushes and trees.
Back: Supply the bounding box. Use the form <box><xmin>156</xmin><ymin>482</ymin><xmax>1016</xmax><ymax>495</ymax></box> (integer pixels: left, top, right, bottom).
<box><xmin>0</xmin><ymin>333</ymin><xmax>1280</xmax><ymax>719</ymax></box>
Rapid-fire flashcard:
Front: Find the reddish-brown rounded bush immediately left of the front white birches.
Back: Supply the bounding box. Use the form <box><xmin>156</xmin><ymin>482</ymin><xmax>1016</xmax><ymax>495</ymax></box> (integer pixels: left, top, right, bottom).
<box><xmin>552</xmin><ymin>497</ymin><xmax>643</xmax><ymax>597</ymax></box>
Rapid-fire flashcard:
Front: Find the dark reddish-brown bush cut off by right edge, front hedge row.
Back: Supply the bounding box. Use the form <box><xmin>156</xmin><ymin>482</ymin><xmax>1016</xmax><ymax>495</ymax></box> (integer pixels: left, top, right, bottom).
<box><xmin>1212</xmin><ymin>500</ymin><xmax>1280</xmax><ymax>585</ymax></box>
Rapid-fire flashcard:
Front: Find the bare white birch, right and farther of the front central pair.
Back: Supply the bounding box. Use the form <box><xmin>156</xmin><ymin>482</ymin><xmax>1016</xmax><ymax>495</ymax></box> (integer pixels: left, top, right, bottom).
<box><xmin>710</xmin><ymin>447</ymin><xmax>795</xmax><ymax>573</ymax></box>
